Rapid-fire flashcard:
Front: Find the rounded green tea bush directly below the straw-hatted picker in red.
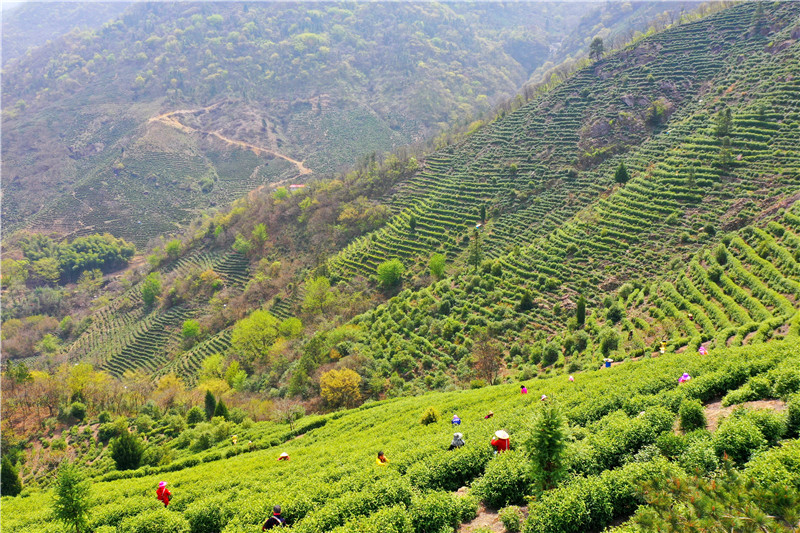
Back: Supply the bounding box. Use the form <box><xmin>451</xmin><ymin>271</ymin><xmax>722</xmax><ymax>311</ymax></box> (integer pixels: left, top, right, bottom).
<box><xmin>473</xmin><ymin>450</ymin><xmax>532</xmax><ymax>509</ymax></box>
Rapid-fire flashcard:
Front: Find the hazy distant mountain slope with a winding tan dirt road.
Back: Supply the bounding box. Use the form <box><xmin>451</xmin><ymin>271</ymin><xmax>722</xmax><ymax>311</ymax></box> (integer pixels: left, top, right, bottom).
<box><xmin>2</xmin><ymin>3</ymin><xmax>693</xmax><ymax>246</ymax></box>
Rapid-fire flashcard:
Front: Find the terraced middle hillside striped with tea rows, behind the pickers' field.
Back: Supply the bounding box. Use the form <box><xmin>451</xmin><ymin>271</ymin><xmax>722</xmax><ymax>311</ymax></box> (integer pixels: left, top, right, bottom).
<box><xmin>21</xmin><ymin>3</ymin><xmax>800</xmax><ymax>397</ymax></box>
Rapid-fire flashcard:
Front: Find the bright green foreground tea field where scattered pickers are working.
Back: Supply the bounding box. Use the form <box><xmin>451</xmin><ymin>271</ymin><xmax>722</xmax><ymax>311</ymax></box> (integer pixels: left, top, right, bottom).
<box><xmin>2</xmin><ymin>338</ymin><xmax>800</xmax><ymax>532</ymax></box>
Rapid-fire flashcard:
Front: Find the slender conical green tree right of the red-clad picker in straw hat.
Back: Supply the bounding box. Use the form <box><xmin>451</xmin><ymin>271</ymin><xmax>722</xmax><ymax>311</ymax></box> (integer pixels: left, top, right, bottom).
<box><xmin>525</xmin><ymin>401</ymin><xmax>567</xmax><ymax>490</ymax></box>
